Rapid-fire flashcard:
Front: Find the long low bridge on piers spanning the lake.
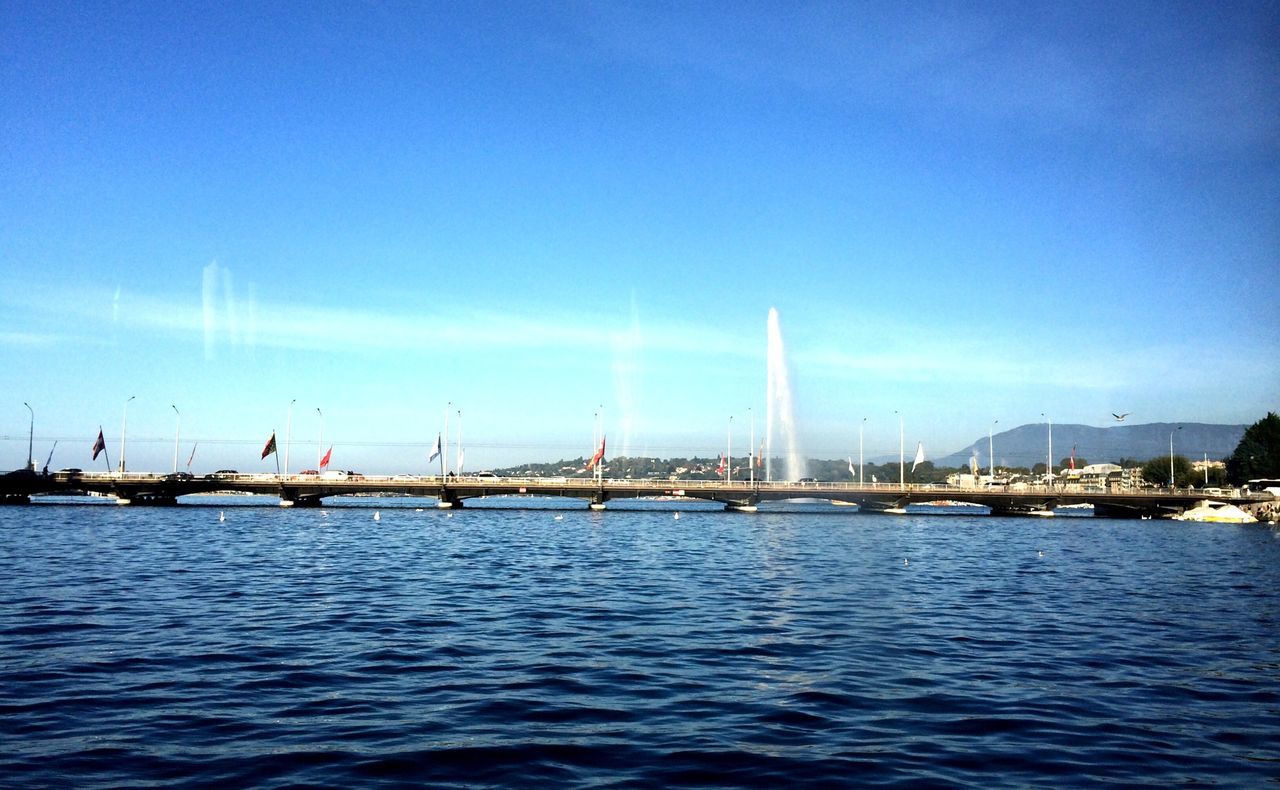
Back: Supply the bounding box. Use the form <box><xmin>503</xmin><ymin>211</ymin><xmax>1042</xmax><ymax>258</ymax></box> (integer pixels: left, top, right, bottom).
<box><xmin>0</xmin><ymin>471</ymin><xmax>1272</xmax><ymax>519</ymax></box>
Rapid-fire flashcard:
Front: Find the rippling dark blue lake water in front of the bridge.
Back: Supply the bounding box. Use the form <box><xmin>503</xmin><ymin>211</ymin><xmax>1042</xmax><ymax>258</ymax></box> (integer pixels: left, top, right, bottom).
<box><xmin>0</xmin><ymin>498</ymin><xmax>1280</xmax><ymax>787</ymax></box>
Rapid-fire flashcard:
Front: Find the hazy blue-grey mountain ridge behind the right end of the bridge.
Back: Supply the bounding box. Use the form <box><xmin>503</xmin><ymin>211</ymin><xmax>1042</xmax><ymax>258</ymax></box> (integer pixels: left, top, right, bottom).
<box><xmin>936</xmin><ymin>423</ymin><xmax>1248</xmax><ymax>467</ymax></box>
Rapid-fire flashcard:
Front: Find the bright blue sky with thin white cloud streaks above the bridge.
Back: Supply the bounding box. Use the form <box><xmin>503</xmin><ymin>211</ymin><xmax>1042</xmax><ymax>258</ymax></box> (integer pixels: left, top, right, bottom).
<box><xmin>0</xmin><ymin>0</ymin><xmax>1280</xmax><ymax>472</ymax></box>
